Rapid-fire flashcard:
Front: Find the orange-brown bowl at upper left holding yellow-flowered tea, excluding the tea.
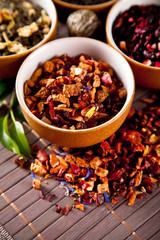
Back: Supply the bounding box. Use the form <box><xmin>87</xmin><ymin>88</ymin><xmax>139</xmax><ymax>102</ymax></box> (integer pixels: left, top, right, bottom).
<box><xmin>0</xmin><ymin>0</ymin><xmax>57</xmax><ymax>80</ymax></box>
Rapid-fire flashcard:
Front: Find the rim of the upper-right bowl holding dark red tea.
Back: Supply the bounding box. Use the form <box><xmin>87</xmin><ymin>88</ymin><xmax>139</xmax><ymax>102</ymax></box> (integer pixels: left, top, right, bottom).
<box><xmin>105</xmin><ymin>0</ymin><xmax>160</xmax><ymax>71</ymax></box>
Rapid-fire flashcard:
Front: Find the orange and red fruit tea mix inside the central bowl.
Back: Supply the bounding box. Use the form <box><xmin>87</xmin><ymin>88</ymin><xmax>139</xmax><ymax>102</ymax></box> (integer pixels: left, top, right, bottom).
<box><xmin>24</xmin><ymin>54</ymin><xmax>127</xmax><ymax>130</ymax></box>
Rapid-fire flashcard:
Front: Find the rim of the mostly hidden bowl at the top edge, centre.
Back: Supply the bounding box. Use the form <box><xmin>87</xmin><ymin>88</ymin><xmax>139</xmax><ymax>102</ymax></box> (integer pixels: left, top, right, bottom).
<box><xmin>53</xmin><ymin>0</ymin><xmax>117</xmax><ymax>10</ymax></box>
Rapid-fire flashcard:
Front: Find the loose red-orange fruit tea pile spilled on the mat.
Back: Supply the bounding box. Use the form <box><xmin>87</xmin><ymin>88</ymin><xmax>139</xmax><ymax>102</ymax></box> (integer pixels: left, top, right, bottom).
<box><xmin>16</xmin><ymin>91</ymin><xmax>160</xmax><ymax>214</ymax></box>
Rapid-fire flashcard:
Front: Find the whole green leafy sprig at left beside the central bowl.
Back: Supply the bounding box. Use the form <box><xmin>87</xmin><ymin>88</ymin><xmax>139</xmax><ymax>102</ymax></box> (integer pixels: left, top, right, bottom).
<box><xmin>0</xmin><ymin>87</ymin><xmax>32</xmax><ymax>159</ymax></box>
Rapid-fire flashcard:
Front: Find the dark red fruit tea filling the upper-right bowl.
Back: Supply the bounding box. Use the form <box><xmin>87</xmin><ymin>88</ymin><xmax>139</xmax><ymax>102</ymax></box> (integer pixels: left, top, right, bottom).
<box><xmin>112</xmin><ymin>5</ymin><xmax>160</xmax><ymax>67</ymax></box>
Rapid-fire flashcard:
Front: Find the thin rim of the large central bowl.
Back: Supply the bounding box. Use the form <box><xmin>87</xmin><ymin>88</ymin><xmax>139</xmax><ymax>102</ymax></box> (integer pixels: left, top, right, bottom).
<box><xmin>15</xmin><ymin>37</ymin><xmax>135</xmax><ymax>134</ymax></box>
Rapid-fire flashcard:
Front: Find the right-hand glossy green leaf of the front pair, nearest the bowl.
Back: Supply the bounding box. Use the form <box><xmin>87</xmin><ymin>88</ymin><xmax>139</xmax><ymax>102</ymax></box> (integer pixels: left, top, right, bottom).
<box><xmin>9</xmin><ymin>116</ymin><xmax>31</xmax><ymax>157</ymax></box>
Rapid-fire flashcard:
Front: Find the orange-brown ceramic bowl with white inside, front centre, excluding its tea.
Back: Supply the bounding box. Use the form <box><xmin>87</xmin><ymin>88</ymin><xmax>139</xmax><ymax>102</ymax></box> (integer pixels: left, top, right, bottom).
<box><xmin>16</xmin><ymin>37</ymin><xmax>135</xmax><ymax>148</ymax></box>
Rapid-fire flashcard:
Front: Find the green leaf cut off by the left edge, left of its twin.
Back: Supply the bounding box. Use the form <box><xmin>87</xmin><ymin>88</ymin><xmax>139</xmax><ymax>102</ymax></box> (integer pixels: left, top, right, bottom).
<box><xmin>0</xmin><ymin>114</ymin><xmax>21</xmax><ymax>156</ymax></box>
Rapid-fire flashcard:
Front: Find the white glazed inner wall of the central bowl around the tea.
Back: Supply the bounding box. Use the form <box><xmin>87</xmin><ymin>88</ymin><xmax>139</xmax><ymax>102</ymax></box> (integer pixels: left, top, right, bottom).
<box><xmin>16</xmin><ymin>37</ymin><xmax>134</xmax><ymax>132</ymax></box>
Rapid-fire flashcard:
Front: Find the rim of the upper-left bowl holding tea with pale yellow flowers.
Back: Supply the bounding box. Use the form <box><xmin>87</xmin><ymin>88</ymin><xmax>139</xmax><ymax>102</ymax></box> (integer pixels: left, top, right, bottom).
<box><xmin>0</xmin><ymin>0</ymin><xmax>58</xmax><ymax>61</ymax></box>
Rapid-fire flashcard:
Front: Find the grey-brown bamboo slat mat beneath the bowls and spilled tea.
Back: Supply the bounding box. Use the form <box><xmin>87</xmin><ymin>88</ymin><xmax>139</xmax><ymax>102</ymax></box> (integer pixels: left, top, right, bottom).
<box><xmin>0</xmin><ymin>17</ymin><xmax>160</xmax><ymax>240</ymax></box>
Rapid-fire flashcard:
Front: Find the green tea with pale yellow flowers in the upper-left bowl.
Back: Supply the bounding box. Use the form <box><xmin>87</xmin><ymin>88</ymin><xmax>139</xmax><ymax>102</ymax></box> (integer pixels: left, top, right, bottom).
<box><xmin>0</xmin><ymin>0</ymin><xmax>51</xmax><ymax>56</ymax></box>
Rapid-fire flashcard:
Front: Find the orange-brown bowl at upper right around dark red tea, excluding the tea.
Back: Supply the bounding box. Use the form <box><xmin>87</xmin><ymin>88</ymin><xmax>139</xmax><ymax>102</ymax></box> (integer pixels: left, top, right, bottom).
<box><xmin>106</xmin><ymin>0</ymin><xmax>160</xmax><ymax>89</ymax></box>
